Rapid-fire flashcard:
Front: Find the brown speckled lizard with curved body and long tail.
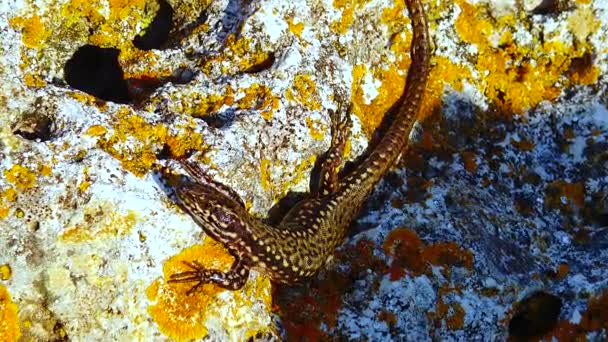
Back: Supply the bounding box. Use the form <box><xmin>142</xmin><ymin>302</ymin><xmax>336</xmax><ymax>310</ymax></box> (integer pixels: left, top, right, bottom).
<box><xmin>169</xmin><ymin>0</ymin><xmax>430</xmax><ymax>294</ymax></box>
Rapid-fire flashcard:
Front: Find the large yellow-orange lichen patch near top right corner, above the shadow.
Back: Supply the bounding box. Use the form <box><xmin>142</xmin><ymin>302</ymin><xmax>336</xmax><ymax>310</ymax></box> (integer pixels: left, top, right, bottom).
<box><xmin>455</xmin><ymin>0</ymin><xmax>599</xmax><ymax>114</ymax></box>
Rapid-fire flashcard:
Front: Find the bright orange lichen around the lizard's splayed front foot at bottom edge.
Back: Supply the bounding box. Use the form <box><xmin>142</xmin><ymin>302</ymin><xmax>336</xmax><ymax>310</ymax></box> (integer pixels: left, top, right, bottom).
<box><xmin>146</xmin><ymin>238</ymin><xmax>271</xmax><ymax>341</ymax></box>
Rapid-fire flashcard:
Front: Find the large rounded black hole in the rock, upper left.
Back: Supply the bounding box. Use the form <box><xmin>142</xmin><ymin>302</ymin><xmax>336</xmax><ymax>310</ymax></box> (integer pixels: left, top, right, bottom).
<box><xmin>63</xmin><ymin>44</ymin><xmax>130</xmax><ymax>103</ymax></box>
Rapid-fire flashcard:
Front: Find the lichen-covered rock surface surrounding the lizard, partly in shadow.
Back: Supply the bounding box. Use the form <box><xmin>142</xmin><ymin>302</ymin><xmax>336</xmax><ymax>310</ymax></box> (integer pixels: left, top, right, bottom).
<box><xmin>0</xmin><ymin>0</ymin><xmax>608</xmax><ymax>341</ymax></box>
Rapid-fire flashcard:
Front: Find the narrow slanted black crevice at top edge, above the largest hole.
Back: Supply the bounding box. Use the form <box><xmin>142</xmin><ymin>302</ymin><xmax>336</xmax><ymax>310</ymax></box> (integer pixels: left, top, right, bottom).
<box><xmin>133</xmin><ymin>0</ymin><xmax>173</xmax><ymax>50</ymax></box>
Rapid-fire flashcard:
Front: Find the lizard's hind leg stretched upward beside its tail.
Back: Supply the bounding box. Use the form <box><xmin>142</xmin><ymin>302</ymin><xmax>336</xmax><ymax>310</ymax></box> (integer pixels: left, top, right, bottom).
<box><xmin>316</xmin><ymin>95</ymin><xmax>352</xmax><ymax>196</ymax></box>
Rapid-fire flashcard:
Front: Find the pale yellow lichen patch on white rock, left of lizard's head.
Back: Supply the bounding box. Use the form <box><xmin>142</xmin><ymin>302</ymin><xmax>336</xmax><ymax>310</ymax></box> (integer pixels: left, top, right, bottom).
<box><xmin>59</xmin><ymin>203</ymin><xmax>137</xmax><ymax>243</ymax></box>
